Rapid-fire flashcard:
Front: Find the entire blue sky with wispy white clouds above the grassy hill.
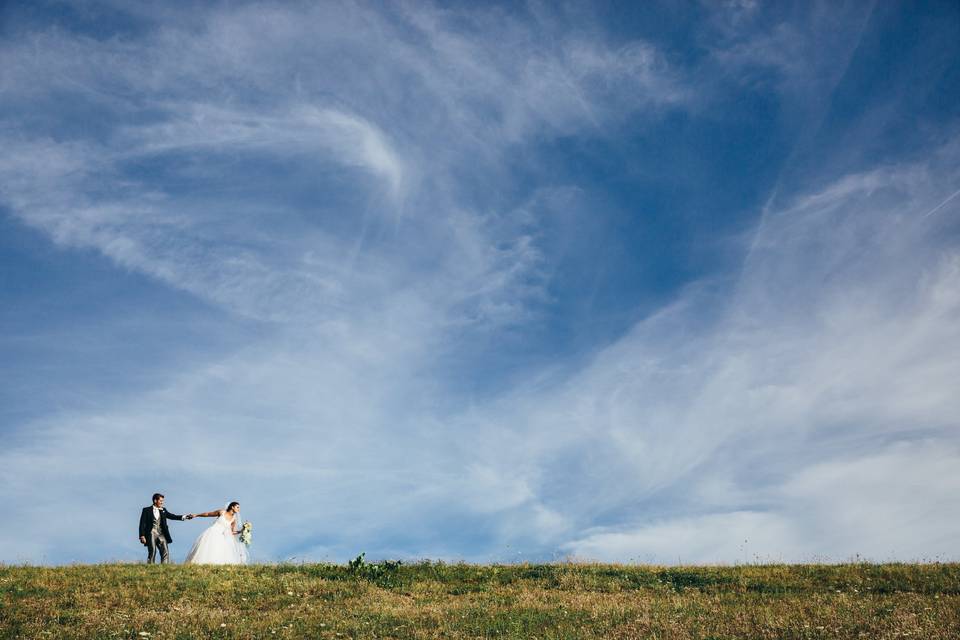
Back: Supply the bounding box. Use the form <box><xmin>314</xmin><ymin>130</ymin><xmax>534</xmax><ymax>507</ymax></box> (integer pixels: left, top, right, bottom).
<box><xmin>0</xmin><ymin>0</ymin><xmax>960</xmax><ymax>564</ymax></box>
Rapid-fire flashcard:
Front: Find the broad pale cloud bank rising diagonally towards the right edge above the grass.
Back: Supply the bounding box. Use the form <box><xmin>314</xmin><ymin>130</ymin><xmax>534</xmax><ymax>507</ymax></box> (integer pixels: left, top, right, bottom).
<box><xmin>454</xmin><ymin>149</ymin><xmax>960</xmax><ymax>562</ymax></box>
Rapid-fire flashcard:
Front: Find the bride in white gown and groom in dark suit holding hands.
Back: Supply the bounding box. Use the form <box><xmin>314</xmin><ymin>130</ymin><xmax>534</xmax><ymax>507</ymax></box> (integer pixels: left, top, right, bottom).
<box><xmin>140</xmin><ymin>493</ymin><xmax>249</xmax><ymax>564</ymax></box>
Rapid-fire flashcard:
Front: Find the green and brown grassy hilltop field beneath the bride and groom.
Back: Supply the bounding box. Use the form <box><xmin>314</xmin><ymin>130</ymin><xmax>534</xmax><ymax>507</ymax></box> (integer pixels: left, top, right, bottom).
<box><xmin>0</xmin><ymin>562</ymin><xmax>960</xmax><ymax>639</ymax></box>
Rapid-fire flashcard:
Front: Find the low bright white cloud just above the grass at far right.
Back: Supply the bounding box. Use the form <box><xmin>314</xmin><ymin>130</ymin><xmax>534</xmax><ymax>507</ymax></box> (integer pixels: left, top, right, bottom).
<box><xmin>562</xmin><ymin>441</ymin><xmax>960</xmax><ymax>564</ymax></box>
